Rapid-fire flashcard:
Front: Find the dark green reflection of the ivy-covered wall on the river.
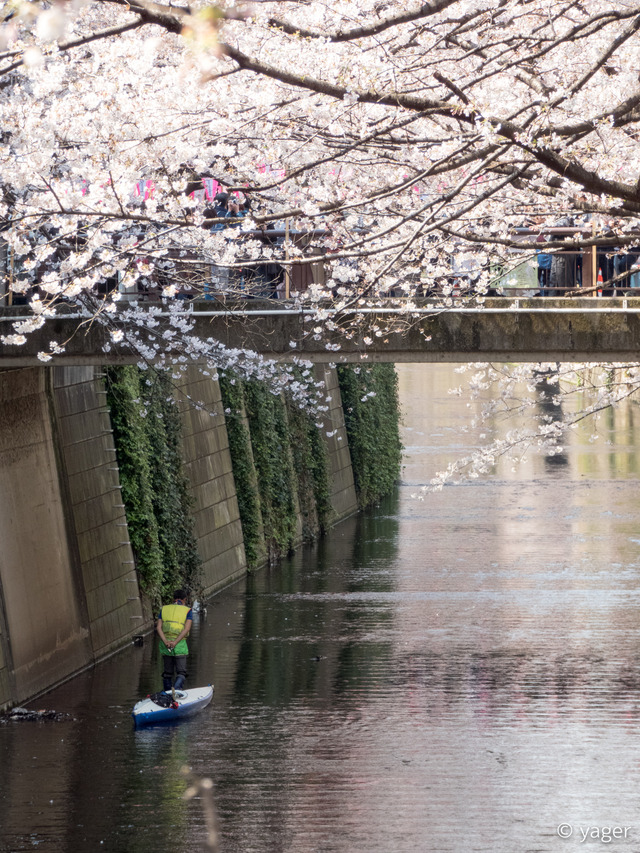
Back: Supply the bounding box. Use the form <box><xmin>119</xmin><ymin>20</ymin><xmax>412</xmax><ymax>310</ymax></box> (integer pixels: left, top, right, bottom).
<box><xmin>230</xmin><ymin>495</ymin><xmax>398</xmax><ymax>705</ymax></box>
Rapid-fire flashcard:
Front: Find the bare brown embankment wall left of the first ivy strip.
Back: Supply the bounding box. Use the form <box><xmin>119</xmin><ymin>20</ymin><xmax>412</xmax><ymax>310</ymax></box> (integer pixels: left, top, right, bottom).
<box><xmin>0</xmin><ymin>367</ymin><xmax>144</xmax><ymax>707</ymax></box>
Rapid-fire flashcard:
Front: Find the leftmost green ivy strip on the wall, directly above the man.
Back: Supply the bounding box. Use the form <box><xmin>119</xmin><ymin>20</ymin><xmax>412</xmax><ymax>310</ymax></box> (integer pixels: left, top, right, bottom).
<box><xmin>106</xmin><ymin>366</ymin><xmax>200</xmax><ymax>606</ymax></box>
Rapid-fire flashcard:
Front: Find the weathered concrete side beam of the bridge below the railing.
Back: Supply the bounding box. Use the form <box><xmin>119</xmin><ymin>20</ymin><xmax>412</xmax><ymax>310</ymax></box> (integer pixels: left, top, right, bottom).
<box><xmin>0</xmin><ymin>297</ymin><xmax>640</xmax><ymax>364</ymax></box>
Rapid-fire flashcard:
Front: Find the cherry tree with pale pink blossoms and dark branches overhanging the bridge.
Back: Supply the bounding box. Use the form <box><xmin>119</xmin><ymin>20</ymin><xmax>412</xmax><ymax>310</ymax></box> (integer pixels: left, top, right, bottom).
<box><xmin>0</xmin><ymin>0</ymin><xmax>640</xmax><ymax>468</ymax></box>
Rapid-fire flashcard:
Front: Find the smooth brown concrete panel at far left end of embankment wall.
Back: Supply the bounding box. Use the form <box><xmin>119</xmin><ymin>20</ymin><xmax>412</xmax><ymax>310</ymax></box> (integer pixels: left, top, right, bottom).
<box><xmin>0</xmin><ymin>368</ymin><xmax>92</xmax><ymax>704</ymax></box>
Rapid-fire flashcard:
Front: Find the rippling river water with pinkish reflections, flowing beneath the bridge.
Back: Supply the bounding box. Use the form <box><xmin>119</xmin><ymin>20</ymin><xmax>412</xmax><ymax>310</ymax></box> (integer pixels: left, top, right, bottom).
<box><xmin>0</xmin><ymin>365</ymin><xmax>640</xmax><ymax>853</ymax></box>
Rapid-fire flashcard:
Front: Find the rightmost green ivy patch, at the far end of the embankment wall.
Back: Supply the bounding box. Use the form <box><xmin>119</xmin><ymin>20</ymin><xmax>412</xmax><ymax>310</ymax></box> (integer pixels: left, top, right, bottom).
<box><xmin>338</xmin><ymin>364</ymin><xmax>402</xmax><ymax>507</ymax></box>
